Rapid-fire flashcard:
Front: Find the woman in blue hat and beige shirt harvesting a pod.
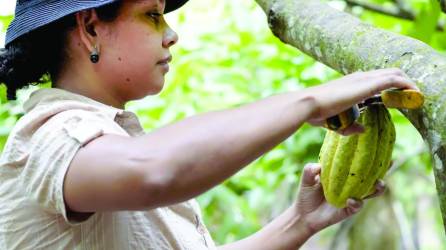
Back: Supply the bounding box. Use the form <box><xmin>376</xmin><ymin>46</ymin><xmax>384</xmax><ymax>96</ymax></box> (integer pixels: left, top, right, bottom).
<box><xmin>0</xmin><ymin>0</ymin><xmax>416</xmax><ymax>249</ymax></box>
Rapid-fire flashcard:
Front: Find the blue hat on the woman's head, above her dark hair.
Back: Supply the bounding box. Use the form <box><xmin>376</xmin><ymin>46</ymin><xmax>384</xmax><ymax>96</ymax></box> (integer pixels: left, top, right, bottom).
<box><xmin>5</xmin><ymin>0</ymin><xmax>188</xmax><ymax>46</ymax></box>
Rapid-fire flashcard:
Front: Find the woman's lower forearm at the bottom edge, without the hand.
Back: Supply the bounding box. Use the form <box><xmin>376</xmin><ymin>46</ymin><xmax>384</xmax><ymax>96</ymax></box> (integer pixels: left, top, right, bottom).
<box><xmin>218</xmin><ymin>207</ymin><xmax>313</xmax><ymax>250</ymax></box>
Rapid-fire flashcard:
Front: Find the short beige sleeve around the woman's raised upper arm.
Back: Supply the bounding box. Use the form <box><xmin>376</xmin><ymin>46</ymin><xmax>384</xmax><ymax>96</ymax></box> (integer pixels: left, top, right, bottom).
<box><xmin>22</xmin><ymin>110</ymin><xmax>122</xmax><ymax>225</ymax></box>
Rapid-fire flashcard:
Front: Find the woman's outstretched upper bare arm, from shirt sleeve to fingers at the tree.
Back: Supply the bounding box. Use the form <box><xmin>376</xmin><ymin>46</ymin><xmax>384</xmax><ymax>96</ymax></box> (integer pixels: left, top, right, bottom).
<box><xmin>64</xmin><ymin>69</ymin><xmax>415</xmax><ymax>212</ymax></box>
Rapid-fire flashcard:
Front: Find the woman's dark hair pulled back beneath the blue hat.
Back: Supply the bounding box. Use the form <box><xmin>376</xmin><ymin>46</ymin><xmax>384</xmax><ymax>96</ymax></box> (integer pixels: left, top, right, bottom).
<box><xmin>0</xmin><ymin>1</ymin><xmax>122</xmax><ymax>100</ymax></box>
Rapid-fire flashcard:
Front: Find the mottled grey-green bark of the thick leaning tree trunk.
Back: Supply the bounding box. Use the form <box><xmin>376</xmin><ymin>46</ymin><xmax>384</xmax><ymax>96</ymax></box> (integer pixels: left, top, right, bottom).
<box><xmin>256</xmin><ymin>0</ymin><xmax>446</xmax><ymax>234</ymax></box>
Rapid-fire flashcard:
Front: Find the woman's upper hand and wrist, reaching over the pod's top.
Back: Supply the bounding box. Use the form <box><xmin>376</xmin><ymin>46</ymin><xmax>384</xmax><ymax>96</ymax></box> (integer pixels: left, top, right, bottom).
<box><xmin>305</xmin><ymin>68</ymin><xmax>419</xmax><ymax>134</ymax></box>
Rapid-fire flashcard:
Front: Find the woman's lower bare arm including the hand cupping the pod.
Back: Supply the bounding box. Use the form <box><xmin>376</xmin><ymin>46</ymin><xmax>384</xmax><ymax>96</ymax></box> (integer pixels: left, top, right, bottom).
<box><xmin>218</xmin><ymin>164</ymin><xmax>385</xmax><ymax>250</ymax></box>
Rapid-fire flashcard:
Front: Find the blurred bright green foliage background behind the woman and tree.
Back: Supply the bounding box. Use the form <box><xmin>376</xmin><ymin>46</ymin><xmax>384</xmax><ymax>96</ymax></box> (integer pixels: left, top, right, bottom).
<box><xmin>0</xmin><ymin>0</ymin><xmax>446</xmax><ymax>250</ymax></box>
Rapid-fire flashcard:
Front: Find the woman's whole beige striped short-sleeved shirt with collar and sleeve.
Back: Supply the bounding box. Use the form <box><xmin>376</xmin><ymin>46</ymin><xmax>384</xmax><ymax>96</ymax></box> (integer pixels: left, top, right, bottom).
<box><xmin>0</xmin><ymin>89</ymin><xmax>215</xmax><ymax>250</ymax></box>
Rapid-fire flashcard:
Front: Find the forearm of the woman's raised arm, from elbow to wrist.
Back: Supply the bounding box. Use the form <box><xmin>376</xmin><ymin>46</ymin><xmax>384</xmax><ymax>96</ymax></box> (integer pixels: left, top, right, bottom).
<box><xmin>137</xmin><ymin>91</ymin><xmax>315</xmax><ymax>203</ymax></box>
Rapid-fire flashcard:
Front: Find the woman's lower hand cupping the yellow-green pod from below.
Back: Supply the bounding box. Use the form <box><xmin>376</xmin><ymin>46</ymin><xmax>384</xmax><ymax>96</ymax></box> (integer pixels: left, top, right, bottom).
<box><xmin>296</xmin><ymin>163</ymin><xmax>385</xmax><ymax>234</ymax></box>
